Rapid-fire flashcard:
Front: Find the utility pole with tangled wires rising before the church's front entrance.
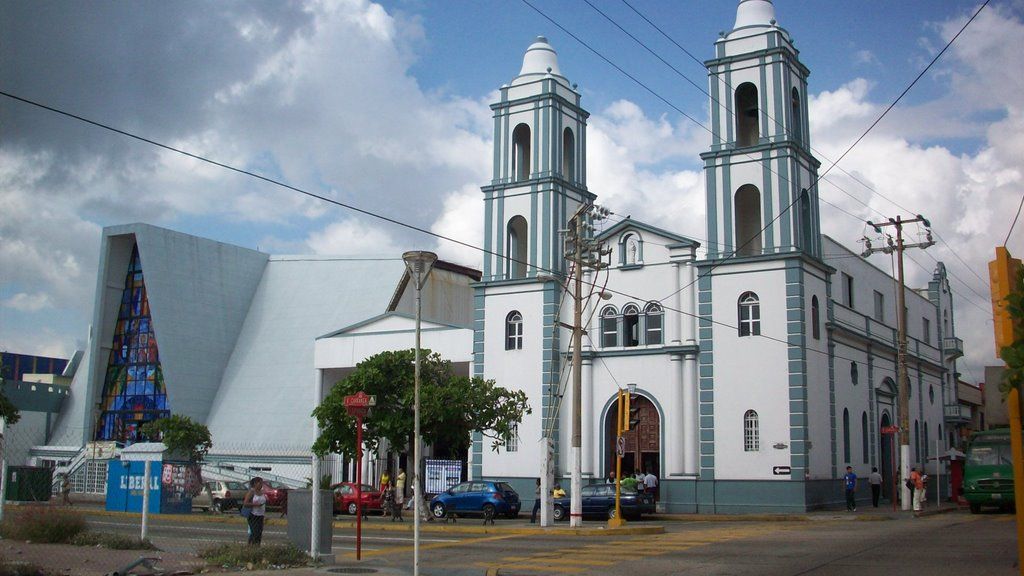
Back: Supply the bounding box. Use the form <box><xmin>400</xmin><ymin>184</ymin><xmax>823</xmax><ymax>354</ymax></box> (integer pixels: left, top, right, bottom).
<box><xmin>556</xmin><ymin>204</ymin><xmax>610</xmax><ymax>528</ymax></box>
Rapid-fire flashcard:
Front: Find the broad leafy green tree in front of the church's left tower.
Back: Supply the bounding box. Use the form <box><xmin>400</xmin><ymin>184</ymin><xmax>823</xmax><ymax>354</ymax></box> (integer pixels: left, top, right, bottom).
<box><xmin>313</xmin><ymin>349</ymin><xmax>531</xmax><ymax>457</ymax></box>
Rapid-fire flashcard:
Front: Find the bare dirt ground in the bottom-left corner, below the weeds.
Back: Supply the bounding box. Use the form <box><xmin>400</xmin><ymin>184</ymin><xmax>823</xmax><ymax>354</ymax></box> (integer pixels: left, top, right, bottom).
<box><xmin>0</xmin><ymin>540</ymin><xmax>207</xmax><ymax>576</ymax></box>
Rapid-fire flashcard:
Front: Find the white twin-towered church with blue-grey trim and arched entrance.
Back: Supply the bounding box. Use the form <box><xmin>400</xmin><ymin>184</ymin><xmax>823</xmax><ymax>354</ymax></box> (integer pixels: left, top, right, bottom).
<box><xmin>471</xmin><ymin>0</ymin><xmax>963</xmax><ymax>512</ymax></box>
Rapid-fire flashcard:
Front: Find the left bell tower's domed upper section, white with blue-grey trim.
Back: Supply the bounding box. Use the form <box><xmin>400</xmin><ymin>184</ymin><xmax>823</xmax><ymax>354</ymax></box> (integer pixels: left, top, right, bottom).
<box><xmin>481</xmin><ymin>36</ymin><xmax>594</xmax><ymax>282</ymax></box>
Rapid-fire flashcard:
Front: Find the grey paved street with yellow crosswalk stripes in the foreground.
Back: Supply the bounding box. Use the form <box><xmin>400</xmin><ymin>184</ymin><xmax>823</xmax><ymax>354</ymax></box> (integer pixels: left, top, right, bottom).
<box><xmin>83</xmin><ymin>511</ymin><xmax>1017</xmax><ymax>576</ymax></box>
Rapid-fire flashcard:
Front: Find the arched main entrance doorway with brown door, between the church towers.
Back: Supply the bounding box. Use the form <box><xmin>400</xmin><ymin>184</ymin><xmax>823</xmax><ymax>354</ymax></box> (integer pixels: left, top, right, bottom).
<box><xmin>604</xmin><ymin>395</ymin><xmax>662</xmax><ymax>478</ymax></box>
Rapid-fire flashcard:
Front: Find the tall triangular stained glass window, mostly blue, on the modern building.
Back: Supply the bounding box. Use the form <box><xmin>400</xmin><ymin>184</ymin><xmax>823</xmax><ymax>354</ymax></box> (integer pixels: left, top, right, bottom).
<box><xmin>96</xmin><ymin>246</ymin><xmax>170</xmax><ymax>444</ymax></box>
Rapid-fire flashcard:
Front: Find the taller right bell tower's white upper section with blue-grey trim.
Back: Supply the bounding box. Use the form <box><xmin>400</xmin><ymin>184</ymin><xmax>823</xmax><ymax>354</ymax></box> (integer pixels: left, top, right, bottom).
<box><xmin>700</xmin><ymin>0</ymin><xmax>821</xmax><ymax>260</ymax></box>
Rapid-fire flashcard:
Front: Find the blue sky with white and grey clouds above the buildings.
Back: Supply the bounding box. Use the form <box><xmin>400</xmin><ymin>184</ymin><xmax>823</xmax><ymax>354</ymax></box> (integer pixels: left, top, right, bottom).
<box><xmin>0</xmin><ymin>0</ymin><xmax>1024</xmax><ymax>382</ymax></box>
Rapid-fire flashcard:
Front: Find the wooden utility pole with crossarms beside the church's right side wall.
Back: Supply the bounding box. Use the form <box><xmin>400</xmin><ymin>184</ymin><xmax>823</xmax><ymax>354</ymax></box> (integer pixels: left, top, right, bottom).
<box><xmin>860</xmin><ymin>214</ymin><xmax>935</xmax><ymax>510</ymax></box>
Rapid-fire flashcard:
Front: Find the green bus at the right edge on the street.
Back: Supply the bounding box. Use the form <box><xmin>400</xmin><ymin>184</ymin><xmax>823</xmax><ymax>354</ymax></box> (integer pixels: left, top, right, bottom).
<box><xmin>964</xmin><ymin>428</ymin><xmax>1014</xmax><ymax>513</ymax></box>
